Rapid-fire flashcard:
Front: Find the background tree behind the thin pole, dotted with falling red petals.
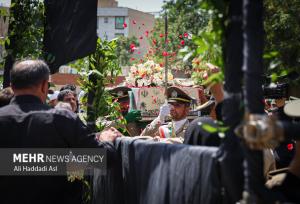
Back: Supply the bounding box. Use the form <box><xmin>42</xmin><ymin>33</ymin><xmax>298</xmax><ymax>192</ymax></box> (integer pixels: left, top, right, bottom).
<box><xmin>147</xmin><ymin>0</ymin><xmax>209</xmax><ymax>69</ymax></box>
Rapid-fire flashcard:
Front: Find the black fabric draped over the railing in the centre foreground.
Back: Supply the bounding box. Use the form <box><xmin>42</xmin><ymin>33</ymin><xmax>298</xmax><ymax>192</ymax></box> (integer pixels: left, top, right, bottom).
<box><xmin>93</xmin><ymin>138</ymin><xmax>221</xmax><ymax>204</ymax></box>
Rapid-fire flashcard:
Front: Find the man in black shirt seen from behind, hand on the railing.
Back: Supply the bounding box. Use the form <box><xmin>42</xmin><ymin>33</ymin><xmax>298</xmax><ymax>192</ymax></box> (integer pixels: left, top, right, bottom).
<box><xmin>0</xmin><ymin>60</ymin><xmax>121</xmax><ymax>204</ymax></box>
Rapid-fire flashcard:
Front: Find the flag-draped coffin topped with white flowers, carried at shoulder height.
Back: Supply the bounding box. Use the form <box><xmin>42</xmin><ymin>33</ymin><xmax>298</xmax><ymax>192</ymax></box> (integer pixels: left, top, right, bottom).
<box><xmin>126</xmin><ymin>60</ymin><xmax>203</xmax><ymax>120</ymax></box>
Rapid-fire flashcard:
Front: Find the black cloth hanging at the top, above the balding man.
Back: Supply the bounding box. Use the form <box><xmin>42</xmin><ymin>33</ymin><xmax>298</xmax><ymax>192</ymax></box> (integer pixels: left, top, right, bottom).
<box><xmin>44</xmin><ymin>0</ymin><xmax>97</xmax><ymax>73</ymax></box>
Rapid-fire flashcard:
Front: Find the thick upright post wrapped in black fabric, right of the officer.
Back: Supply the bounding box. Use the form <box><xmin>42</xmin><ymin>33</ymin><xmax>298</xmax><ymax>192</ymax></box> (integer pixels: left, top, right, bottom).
<box><xmin>218</xmin><ymin>0</ymin><xmax>244</xmax><ymax>203</ymax></box>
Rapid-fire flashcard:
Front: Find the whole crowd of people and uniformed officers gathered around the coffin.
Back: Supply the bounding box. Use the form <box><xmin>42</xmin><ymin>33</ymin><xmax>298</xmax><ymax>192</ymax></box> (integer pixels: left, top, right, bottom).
<box><xmin>0</xmin><ymin>60</ymin><xmax>300</xmax><ymax>203</ymax></box>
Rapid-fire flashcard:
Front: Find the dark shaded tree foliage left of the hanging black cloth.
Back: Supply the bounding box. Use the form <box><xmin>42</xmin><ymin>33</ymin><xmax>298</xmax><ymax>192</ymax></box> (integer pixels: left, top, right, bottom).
<box><xmin>5</xmin><ymin>0</ymin><xmax>44</xmax><ymax>59</ymax></box>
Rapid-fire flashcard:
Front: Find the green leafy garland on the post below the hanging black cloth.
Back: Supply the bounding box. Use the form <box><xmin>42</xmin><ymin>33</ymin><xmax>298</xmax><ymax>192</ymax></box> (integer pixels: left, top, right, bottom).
<box><xmin>75</xmin><ymin>38</ymin><xmax>125</xmax><ymax>131</ymax></box>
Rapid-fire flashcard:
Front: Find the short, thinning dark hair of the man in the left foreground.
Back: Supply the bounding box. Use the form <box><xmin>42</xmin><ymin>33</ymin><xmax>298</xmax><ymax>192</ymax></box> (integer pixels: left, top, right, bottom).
<box><xmin>10</xmin><ymin>60</ymin><xmax>50</xmax><ymax>89</ymax></box>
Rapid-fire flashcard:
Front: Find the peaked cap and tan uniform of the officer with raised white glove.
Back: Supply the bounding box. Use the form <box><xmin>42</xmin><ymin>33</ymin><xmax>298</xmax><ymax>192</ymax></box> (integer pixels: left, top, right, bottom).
<box><xmin>141</xmin><ymin>87</ymin><xmax>192</xmax><ymax>142</ymax></box>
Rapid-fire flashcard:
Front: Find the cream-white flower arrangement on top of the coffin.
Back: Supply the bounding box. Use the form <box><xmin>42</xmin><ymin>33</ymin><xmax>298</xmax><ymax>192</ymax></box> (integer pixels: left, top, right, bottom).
<box><xmin>126</xmin><ymin>60</ymin><xmax>173</xmax><ymax>87</ymax></box>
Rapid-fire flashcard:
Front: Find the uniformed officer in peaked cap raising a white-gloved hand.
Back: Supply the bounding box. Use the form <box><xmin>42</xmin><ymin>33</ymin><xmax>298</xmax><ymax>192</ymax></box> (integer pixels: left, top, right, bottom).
<box><xmin>141</xmin><ymin>86</ymin><xmax>193</xmax><ymax>143</ymax></box>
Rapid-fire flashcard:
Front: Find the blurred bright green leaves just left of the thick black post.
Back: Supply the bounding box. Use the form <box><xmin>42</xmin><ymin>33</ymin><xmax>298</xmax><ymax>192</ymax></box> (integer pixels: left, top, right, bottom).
<box><xmin>170</xmin><ymin>0</ymin><xmax>228</xmax><ymax>85</ymax></box>
